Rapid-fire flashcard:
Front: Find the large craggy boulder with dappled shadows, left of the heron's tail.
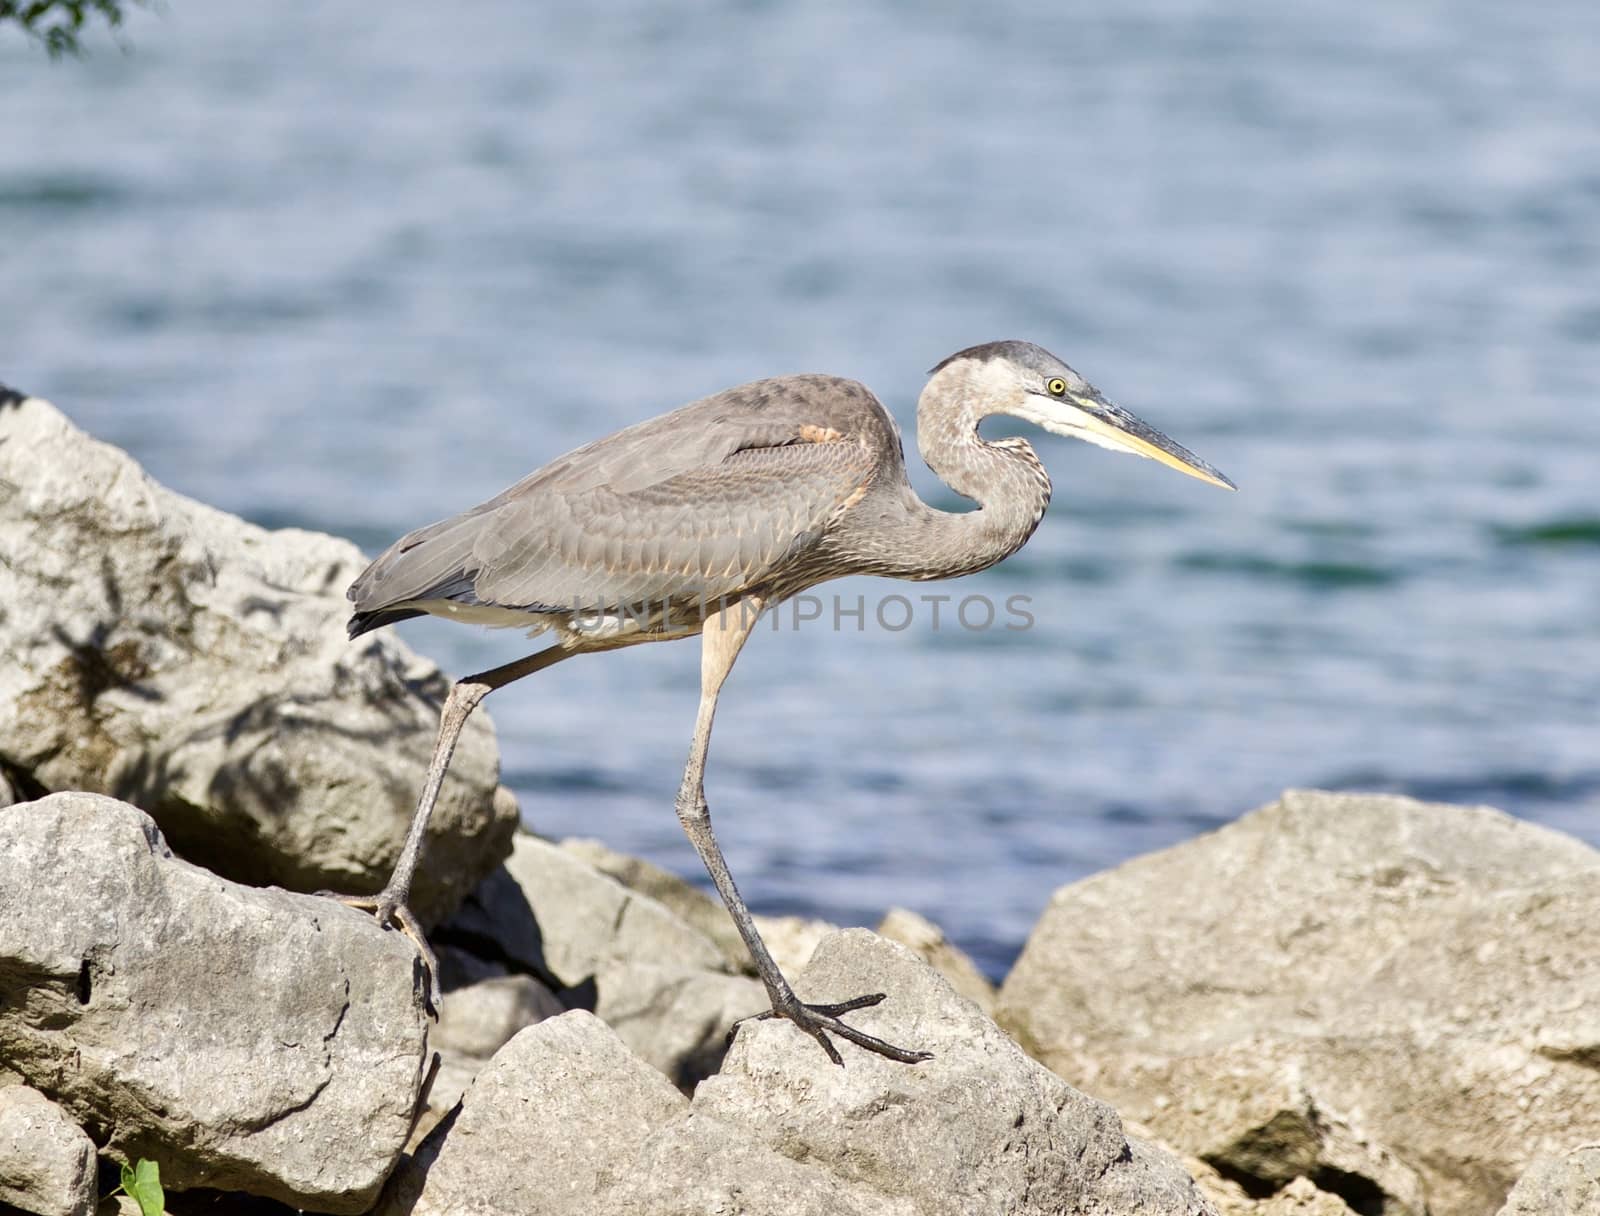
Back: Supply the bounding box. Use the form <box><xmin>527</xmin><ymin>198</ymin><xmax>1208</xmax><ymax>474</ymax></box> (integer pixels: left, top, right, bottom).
<box><xmin>0</xmin><ymin>398</ymin><xmax>517</xmax><ymax>923</ymax></box>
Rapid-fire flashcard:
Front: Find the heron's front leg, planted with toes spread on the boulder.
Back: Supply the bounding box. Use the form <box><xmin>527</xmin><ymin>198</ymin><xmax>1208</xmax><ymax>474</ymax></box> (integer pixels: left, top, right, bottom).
<box><xmin>677</xmin><ymin>597</ymin><xmax>933</xmax><ymax>1066</ymax></box>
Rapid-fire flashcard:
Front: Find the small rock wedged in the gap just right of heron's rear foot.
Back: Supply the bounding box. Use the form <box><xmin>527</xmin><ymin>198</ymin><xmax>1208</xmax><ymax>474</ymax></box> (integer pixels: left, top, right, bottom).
<box><xmin>411</xmin><ymin>946</ymin><xmax>566</xmax><ymax>1144</ymax></box>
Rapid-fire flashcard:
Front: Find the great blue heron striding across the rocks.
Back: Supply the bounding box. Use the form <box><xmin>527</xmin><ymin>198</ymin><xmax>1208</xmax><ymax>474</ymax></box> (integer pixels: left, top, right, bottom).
<box><xmin>340</xmin><ymin>341</ymin><xmax>1234</xmax><ymax>1064</ymax></box>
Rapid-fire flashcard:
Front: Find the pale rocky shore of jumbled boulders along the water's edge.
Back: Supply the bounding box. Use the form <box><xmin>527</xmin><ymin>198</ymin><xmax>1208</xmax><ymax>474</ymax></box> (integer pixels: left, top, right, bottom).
<box><xmin>0</xmin><ymin>392</ymin><xmax>1600</xmax><ymax>1216</ymax></box>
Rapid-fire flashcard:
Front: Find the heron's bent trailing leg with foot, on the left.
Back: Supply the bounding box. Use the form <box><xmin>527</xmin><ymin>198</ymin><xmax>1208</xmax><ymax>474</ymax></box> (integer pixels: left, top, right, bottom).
<box><xmin>333</xmin><ymin>646</ymin><xmax>578</xmax><ymax>1013</ymax></box>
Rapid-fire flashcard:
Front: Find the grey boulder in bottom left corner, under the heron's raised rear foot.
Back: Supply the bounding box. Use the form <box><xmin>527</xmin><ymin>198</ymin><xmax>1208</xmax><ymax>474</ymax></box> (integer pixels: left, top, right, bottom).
<box><xmin>0</xmin><ymin>794</ymin><xmax>426</xmax><ymax>1213</ymax></box>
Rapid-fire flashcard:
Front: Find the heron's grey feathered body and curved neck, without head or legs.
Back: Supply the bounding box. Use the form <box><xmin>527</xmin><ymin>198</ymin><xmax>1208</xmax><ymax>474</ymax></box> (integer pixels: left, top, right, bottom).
<box><xmin>350</xmin><ymin>347</ymin><xmax>1068</xmax><ymax>640</ymax></box>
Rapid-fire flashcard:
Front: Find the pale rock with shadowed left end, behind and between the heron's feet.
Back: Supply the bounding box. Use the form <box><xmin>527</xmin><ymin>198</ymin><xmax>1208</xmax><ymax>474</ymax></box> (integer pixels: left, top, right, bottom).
<box><xmin>443</xmin><ymin>834</ymin><xmax>768</xmax><ymax>1088</ymax></box>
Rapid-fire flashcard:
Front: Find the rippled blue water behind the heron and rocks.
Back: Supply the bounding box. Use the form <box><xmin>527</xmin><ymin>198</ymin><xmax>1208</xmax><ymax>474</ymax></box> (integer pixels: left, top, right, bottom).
<box><xmin>0</xmin><ymin>0</ymin><xmax>1600</xmax><ymax>973</ymax></box>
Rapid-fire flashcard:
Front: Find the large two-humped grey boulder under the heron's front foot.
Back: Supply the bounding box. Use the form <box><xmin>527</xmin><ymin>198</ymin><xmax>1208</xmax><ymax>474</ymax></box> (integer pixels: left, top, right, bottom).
<box><xmin>381</xmin><ymin>930</ymin><xmax>1214</xmax><ymax>1216</ymax></box>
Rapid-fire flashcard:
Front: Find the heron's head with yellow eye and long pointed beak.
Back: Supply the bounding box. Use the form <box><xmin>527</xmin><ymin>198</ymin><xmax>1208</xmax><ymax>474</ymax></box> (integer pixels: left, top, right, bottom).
<box><xmin>933</xmin><ymin>342</ymin><xmax>1238</xmax><ymax>490</ymax></box>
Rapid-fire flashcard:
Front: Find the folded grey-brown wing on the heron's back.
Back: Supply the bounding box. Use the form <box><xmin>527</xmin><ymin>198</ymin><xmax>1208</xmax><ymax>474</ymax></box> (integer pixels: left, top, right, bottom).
<box><xmin>349</xmin><ymin>376</ymin><xmax>898</xmax><ymax>629</ymax></box>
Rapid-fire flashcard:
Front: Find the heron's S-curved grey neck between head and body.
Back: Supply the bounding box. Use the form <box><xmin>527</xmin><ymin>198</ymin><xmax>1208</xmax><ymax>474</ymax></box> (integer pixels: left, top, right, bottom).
<box><xmin>885</xmin><ymin>368</ymin><xmax>1050</xmax><ymax>579</ymax></box>
